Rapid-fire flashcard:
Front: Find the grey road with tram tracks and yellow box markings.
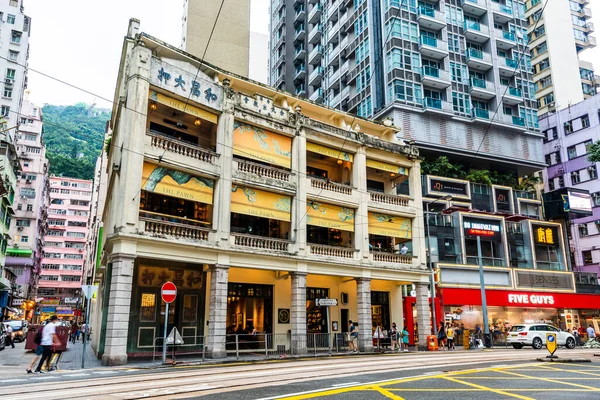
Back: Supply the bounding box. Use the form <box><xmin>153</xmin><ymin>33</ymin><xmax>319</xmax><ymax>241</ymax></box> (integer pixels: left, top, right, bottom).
<box><xmin>0</xmin><ymin>349</ymin><xmax>600</xmax><ymax>400</ymax></box>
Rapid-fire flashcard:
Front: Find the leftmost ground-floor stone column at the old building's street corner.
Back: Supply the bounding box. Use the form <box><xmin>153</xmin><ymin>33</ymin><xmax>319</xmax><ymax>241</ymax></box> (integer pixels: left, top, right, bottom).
<box><xmin>102</xmin><ymin>253</ymin><xmax>135</xmax><ymax>365</ymax></box>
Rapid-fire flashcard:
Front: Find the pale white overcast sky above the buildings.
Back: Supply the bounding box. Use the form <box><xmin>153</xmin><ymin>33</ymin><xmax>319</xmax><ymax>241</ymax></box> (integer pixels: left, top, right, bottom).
<box><xmin>24</xmin><ymin>0</ymin><xmax>600</xmax><ymax>108</ymax></box>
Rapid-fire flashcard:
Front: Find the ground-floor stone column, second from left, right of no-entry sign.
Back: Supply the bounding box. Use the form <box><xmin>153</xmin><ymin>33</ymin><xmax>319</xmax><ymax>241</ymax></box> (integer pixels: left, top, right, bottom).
<box><xmin>206</xmin><ymin>264</ymin><xmax>229</xmax><ymax>358</ymax></box>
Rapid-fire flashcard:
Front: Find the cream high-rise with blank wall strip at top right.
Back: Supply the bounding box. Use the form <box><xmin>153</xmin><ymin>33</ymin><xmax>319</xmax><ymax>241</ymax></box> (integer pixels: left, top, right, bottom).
<box><xmin>525</xmin><ymin>0</ymin><xmax>596</xmax><ymax>115</ymax></box>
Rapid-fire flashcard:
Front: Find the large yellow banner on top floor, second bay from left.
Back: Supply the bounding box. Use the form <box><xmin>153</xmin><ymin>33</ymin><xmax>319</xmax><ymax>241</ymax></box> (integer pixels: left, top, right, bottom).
<box><xmin>233</xmin><ymin>121</ymin><xmax>292</xmax><ymax>168</ymax></box>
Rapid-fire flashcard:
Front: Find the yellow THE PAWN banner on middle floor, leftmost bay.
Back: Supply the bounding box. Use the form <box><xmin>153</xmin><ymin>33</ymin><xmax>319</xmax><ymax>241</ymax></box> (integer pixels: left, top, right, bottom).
<box><xmin>142</xmin><ymin>163</ymin><xmax>215</xmax><ymax>204</ymax></box>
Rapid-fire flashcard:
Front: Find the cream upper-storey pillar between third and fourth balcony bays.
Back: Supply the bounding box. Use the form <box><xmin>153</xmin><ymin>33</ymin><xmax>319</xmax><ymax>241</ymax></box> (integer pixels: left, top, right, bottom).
<box><xmin>352</xmin><ymin>147</ymin><xmax>370</xmax><ymax>260</ymax></box>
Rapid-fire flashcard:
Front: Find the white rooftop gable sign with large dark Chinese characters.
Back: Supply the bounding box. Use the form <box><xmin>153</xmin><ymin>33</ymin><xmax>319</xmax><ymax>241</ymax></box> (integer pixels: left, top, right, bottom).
<box><xmin>151</xmin><ymin>57</ymin><xmax>223</xmax><ymax>110</ymax></box>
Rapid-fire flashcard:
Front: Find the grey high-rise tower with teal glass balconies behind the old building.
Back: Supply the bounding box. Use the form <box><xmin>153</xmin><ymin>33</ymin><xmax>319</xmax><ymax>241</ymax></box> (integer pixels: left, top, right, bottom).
<box><xmin>270</xmin><ymin>0</ymin><xmax>543</xmax><ymax>173</ymax></box>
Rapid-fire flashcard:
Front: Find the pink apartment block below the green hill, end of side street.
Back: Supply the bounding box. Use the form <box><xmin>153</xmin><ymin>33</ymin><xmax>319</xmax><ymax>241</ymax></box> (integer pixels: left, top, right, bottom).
<box><xmin>38</xmin><ymin>176</ymin><xmax>92</xmax><ymax>319</ymax></box>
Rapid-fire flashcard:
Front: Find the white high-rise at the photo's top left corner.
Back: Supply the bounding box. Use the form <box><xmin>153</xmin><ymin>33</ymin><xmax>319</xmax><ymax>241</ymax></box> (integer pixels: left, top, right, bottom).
<box><xmin>0</xmin><ymin>0</ymin><xmax>31</xmax><ymax>134</ymax></box>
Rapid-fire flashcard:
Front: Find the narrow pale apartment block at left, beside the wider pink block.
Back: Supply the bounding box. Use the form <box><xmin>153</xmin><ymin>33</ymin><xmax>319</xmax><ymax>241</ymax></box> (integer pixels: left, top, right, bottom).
<box><xmin>6</xmin><ymin>100</ymin><xmax>48</xmax><ymax>298</ymax></box>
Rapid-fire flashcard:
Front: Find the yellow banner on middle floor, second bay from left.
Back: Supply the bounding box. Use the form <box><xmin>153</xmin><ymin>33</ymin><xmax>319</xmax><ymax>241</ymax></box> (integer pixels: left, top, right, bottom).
<box><xmin>231</xmin><ymin>185</ymin><xmax>292</xmax><ymax>222</ymax></box>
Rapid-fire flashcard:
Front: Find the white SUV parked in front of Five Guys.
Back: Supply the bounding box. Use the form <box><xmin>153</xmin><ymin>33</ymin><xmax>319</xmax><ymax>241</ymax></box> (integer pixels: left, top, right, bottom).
<box><xmin>508</xmin><ymin>324</ymin><xmax>575</xmax><ymax>350</ymax></box>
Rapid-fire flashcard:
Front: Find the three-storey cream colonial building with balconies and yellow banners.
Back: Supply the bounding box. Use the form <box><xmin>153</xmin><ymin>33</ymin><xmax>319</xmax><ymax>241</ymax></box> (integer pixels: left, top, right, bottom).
<box><xmin>94</xmin><ymin>20</ymin><xmax>430</xmax><ymax>365</ymax></box>
